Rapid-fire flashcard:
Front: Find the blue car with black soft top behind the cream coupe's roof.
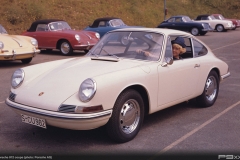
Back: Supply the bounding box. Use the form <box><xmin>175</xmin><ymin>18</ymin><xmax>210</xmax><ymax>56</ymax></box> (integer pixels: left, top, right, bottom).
<box><xmin>84</xmin><ymin>17</ymin><xmax>140</xmax><ymax>38</ymax></box>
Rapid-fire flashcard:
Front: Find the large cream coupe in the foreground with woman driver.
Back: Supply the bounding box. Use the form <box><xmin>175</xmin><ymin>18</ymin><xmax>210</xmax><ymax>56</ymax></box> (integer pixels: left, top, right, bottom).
<box><xmin>6</xmin><ymin>28</ymin><xmax>230</xmax><ymax>142</ymax></box>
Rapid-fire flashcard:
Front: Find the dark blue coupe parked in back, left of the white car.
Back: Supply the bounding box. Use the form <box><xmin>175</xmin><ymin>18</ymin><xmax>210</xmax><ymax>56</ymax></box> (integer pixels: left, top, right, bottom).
<box><xmin>157</xmin><ymin>15</ymin><xmax>213</xmax><ymax>36</ymax></box>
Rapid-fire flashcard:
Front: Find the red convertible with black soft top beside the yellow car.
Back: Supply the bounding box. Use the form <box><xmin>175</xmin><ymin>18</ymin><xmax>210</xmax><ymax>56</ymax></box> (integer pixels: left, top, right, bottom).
<box><xmin>22</xmin><ymin>19</ymin><xmax>100</xmax><ymax>55</ymax></box>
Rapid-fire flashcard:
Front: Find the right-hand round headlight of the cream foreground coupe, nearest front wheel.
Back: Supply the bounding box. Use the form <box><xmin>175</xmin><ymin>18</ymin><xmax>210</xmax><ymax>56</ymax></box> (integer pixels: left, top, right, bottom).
<box><xmin>78</xmin><ymin>78</ymin><xmax>97</xmax><ymax>102</ymax></box>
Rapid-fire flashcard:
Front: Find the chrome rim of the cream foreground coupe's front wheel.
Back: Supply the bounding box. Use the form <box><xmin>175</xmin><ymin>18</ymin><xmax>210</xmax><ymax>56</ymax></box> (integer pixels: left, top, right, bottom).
<box><xmin>119</xmin><ymin>99</ymin><xmax>140</xmax><ymax>134</ymax></box>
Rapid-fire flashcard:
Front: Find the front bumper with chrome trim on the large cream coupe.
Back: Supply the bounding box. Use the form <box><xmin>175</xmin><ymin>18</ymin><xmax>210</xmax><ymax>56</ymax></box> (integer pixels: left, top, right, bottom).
<box><xmin>5</xmin><ymin>98</ymin><xmax>112</xmax><ymax>130</ymax></box>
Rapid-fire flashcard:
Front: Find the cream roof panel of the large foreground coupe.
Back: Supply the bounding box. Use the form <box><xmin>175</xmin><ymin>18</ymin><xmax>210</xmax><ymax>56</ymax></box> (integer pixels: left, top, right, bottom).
<box><xmin>107</xmin><ymin>27</ymin><xmax>192</xmax><ymax>37</ymax></box>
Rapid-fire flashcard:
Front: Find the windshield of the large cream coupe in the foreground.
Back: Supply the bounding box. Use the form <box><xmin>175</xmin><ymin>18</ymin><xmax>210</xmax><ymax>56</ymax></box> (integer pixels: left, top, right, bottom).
<box><xmin>87</xmin><ymin>31</ymin><xmax>163</xmax><ymax>61</ymax></box>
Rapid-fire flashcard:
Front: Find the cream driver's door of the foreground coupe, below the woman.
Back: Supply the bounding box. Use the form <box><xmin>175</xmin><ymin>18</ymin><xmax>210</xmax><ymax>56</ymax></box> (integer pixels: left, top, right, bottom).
<box><xmin>158</xmin><ymin>37</ymin><xmax>200</xmax><ymax>108</ymax></box>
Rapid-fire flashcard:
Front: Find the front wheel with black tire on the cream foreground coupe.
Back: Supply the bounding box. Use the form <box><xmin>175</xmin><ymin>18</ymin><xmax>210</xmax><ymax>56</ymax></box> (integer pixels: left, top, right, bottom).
<box><xmin>106</xmin><ymin>89</ymin><xmax>144</xmax><ymax>143</ymax></box>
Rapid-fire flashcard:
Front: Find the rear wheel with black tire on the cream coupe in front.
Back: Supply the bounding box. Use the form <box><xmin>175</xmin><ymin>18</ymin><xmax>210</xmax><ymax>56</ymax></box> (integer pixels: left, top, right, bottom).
<box><xmin>197</xmin><ymin>71</ymin><xmax>219</xmax><ymax>107</ymax></box>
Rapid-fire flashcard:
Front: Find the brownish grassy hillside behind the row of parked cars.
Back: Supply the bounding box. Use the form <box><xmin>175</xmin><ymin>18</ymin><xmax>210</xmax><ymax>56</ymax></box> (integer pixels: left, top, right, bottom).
<box><xmin>0</xmin><ymin>0</ymin><xmax>240</xmax><ymax>34</ymax></box>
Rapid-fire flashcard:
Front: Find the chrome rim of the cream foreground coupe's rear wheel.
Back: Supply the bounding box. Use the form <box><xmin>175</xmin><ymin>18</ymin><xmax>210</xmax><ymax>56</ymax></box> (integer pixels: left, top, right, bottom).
<box><xmin>205</xmin><ymin>76</ymin><xmax>217</xmax><ymax>101</ymax></box>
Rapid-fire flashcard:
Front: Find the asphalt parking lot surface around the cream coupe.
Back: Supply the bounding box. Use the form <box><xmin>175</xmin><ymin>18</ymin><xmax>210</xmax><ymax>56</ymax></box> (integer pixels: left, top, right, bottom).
<box><xmin>0</xmin><ymin>29</ymin><xmax>240</xmax><ymax>160</ymax></box>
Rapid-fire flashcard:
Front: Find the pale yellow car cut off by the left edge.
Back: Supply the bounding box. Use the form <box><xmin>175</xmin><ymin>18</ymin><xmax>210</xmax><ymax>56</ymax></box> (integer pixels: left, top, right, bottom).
<box><xmin>0</xmin><ymin>24</ymin><xmax>40</xmax><ymax>63</ymax></box>
